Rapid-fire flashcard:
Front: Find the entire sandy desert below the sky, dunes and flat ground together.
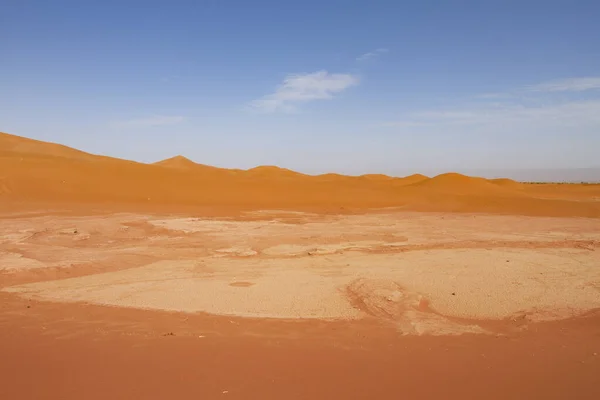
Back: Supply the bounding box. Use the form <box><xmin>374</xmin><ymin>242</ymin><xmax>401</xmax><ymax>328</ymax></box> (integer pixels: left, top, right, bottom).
<box><xmin>0</xmin><ymin>133</ymin><xmax>600</xmax><ymax>399</ymax></box>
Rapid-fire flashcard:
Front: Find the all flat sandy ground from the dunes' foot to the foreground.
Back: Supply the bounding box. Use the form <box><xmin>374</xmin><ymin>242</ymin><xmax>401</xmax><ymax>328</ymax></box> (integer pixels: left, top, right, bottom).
<box><xmin>0</xmin><ymin>210</ymin><xmax>600</xmax><ymax>399</ymax></box>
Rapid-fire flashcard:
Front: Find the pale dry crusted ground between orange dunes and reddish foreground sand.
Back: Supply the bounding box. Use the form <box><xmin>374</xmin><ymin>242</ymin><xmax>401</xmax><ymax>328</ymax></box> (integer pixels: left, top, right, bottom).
<box><xmin>0</xmin><ymin>210</ymin><xmax>600</xmax><ymax>335</ymax></box>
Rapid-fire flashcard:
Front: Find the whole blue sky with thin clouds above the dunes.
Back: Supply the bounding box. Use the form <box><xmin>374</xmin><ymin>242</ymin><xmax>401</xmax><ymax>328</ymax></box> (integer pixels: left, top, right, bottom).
<box><xmin>0</xmin><ymin>0</ymin><xmax>600</xmax><ymax>175</ymax></box>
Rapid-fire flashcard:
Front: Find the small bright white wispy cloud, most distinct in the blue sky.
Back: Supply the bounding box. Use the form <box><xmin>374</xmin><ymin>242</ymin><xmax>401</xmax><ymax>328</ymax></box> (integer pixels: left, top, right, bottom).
<box><xmin>250</xmin><ymin>70</ymin><xmax>359</xmax><ymax>112</ymax></box>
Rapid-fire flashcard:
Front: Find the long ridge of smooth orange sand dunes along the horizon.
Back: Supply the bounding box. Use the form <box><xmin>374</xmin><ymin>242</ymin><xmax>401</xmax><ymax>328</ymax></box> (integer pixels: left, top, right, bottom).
<box><xmin>0</xmin><ymin>133</ymin><xmax>600</xmax><ymax>217</ymax></box>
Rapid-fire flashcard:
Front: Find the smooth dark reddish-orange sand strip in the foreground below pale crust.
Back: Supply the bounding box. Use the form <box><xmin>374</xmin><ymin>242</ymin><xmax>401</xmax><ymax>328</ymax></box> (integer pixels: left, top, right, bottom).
<box><xmin>0</xmin><ymin>293</ymin><xmax>600</xmax><ymax>400</ymax></box>
